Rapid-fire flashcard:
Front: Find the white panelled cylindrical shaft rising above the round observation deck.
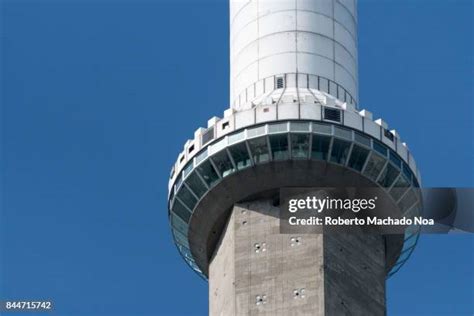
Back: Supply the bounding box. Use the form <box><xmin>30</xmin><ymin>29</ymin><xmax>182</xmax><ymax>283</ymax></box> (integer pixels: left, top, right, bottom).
<box><xmin>230</xmin><ymin>0</ymin><xmax>358</xmax><ymax>110</ymax></box>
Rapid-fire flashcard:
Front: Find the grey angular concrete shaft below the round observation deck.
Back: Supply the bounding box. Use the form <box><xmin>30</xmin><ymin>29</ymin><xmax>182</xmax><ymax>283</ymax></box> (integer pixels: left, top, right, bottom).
<box><xmin>209</xmin><ymin>200</ymin><xmax>386</xmax><ymax>316</ymax></box>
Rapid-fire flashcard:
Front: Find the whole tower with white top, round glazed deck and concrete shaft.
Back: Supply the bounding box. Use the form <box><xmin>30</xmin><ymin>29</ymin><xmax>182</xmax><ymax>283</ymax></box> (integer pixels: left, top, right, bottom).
<box><xmin>168</xmin><ymin>0</ymin><xmax>421</xmax><ymax>315</ymax></box>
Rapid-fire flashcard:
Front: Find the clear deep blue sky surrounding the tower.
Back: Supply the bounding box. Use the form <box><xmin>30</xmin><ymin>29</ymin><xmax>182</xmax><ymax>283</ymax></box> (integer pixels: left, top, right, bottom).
<box><xmin>0</xmin><ymin>0</ymin><xmax>474</xmax><ymax>316</ymax></box>
